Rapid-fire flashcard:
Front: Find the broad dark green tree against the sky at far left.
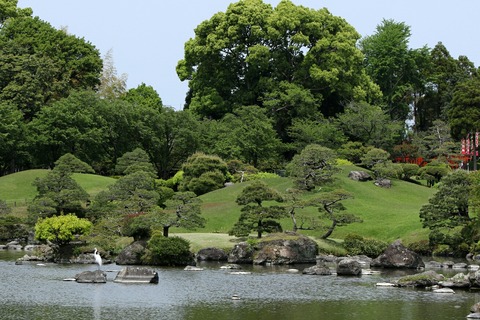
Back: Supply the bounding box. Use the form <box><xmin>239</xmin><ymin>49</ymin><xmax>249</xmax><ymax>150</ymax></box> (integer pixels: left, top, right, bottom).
<box><xmin>0</xmin><ymin>15</ymin><xmax>102</xmax><ymax>119</ymax></box>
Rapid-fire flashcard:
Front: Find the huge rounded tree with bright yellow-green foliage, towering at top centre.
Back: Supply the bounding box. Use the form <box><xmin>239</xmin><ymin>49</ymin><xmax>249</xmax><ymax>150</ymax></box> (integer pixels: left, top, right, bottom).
<box><xmin>177</xmin><ymin>0</ymin><xmax>380</xmax><ymax>122</ymax></box>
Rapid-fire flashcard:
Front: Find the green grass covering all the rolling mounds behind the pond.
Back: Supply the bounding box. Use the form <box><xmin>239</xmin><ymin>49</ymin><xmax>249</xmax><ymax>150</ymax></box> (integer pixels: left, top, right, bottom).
<box><xmin>0</xmin><ymin>166</ymin><xmax>435</xmax><ymax>242</ymax></box>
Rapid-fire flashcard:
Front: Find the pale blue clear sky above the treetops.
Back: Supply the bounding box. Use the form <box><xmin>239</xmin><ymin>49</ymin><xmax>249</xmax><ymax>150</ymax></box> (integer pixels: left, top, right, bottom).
<box><xmin>18</xmin><ymin>0</ymin><xmax>480</xmax><ymax>110</ymax></box>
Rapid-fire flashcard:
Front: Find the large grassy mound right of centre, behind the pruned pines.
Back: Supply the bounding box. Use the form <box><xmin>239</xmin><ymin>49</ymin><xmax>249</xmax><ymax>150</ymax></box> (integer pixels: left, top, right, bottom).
<box><xmin>195</xmin><ymin>166</ymin><xmax>434</xmax><ymax>242</ymax></box>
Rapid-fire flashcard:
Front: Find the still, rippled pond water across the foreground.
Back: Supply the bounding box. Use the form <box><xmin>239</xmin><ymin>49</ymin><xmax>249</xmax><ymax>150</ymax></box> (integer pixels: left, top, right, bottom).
<box><xmin>0</xmin><ymin>251</ymin><xmax>480</xmax><ymax>320</ymax></box>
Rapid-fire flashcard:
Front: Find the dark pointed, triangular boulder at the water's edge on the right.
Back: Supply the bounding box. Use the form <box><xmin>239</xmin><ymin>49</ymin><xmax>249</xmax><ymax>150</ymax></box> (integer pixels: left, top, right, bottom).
<box><xmin>370</xmin><ymin>240</ymin><xmax>425</xmax><ymax>269</ymax></box>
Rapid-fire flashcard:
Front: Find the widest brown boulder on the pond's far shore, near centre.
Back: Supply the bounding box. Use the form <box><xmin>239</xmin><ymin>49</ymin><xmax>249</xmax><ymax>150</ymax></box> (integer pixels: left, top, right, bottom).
<box><xmin>253</xmin><ymin>233</ymin><xmax>318</xmax><ymax>265</ymax></box>
